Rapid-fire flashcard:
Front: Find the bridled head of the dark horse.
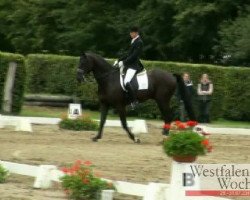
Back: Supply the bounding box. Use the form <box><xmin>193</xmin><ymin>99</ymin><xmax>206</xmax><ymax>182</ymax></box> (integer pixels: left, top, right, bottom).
<box><xmin>76</xmin><ymin>53</ymin><xmax>92</xmax><ymax>83</ymax></box>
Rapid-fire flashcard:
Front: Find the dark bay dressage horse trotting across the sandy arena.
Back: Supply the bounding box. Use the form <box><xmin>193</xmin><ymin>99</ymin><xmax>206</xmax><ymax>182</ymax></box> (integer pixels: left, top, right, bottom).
<box><xmin>77</xmin><ymin>53</ymin><xmax>195</xmax><ymax>142</ymax></box>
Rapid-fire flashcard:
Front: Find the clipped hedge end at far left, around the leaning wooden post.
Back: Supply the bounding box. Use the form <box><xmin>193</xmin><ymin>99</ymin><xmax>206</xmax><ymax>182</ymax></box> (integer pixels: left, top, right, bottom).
<box><xmin>0</xmin><ymin>52</ymin><xmax>26</xmax><ymax>113</ymax></box>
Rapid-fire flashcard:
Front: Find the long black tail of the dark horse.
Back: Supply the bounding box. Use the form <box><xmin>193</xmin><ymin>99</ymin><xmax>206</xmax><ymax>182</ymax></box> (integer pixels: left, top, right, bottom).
<box><xmin>173</xmin><ymin>74</ymin><xmax>196</xmax><ymax>120</ymax></box>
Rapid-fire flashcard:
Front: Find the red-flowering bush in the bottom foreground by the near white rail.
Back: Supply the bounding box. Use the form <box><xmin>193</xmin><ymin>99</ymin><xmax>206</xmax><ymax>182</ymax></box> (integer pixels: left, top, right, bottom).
<box><xmin>61</xmin><ymin>160</ymin><xmax>115</xmax><ymax>200</ymax></box>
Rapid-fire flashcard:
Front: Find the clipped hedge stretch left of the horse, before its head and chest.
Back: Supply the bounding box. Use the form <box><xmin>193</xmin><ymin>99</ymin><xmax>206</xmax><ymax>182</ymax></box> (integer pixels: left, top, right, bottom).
<box><xmin>26</xmin><ymin>54</ymin><xmax>98</xmax><ymax>108</ymax></box>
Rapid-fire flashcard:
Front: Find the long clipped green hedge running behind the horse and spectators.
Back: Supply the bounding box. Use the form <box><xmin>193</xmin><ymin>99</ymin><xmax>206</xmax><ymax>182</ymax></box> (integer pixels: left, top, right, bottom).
<box><xmin>27</xmin><ymin>54</ymin><xmax>250</xmax><ymax>120</ymax></box>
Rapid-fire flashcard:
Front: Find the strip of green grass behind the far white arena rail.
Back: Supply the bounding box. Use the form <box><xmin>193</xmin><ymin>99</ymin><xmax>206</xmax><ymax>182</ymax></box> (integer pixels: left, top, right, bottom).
<box><xmin>20</xmin><ymin>106</ymin><xmax>250</xmax><ymax>128</ymax></box>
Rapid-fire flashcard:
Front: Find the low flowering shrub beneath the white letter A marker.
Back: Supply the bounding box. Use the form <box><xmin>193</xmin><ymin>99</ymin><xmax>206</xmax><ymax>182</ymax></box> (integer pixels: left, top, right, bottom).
<box><xmin>59</xmin><ymin>116</ymin><xmax>98</xmax><ymax>131</ymax></box>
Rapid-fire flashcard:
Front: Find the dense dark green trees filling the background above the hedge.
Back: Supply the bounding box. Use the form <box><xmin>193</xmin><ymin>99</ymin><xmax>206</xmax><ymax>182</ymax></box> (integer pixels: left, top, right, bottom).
<box><xmin>0</xmin><ymin>0</ymin><xmax>250</xmax><ymax>65</ymax></box>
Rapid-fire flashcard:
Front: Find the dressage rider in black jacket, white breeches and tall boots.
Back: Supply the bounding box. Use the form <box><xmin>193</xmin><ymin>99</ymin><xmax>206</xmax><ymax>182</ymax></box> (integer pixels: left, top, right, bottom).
<box><xmin>114</xmin><ymin>27</ymin><xmax>144</xmax><ymax>109</ymax></box>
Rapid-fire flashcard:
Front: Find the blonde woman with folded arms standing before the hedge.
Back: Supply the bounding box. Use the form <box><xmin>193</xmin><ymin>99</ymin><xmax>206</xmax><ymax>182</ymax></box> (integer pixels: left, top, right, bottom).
<box><xmin>197</xmin><ymin>74</ymin><xmax>213</xmax><ymax>123</ymax></box>
